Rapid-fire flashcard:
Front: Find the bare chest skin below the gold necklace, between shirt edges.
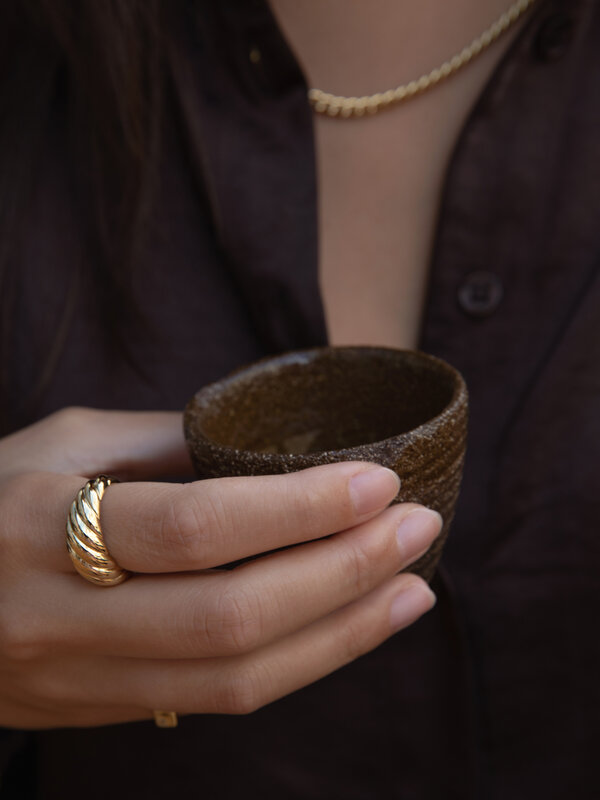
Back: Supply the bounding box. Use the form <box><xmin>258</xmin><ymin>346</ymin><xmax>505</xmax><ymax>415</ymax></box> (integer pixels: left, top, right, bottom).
<box><xmin>316</xmin><ymin>44</ymin><xmax>520</xmax><ymax>348</ymax></box>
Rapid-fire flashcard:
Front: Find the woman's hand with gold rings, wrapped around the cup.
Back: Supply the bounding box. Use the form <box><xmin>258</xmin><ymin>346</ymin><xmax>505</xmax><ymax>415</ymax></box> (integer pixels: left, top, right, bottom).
<box><xmin>0</xmin><ymin>409</ymin><xmax>441</xmax><ymax>728</ymax></box>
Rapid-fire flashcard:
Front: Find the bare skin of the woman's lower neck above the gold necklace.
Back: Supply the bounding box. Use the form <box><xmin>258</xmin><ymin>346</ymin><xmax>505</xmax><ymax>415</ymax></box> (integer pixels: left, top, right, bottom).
<box><xmin>270</xmin><ymin>0</ymin><xmax>528</xmax><ymax>96</ymax></box>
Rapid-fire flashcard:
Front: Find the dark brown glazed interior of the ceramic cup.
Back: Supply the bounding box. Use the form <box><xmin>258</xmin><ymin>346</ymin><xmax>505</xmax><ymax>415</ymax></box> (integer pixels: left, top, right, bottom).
<box><xmin>193</xmin><ymin>347</ymin><xmax>460</xmax><ymax>454</ymax></box>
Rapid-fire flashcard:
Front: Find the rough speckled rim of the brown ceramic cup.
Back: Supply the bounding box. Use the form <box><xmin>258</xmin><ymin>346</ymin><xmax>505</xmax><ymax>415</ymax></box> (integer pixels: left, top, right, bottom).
<box><xmin>184</xmin><ymin>345</ymin><xmax>468</xmax><ymax>464</ymax></box>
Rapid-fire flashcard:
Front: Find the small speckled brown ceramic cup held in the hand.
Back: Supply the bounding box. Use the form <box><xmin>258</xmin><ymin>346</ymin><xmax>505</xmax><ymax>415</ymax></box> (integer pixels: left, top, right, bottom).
<box><xmin>184</xmin><ymin>347</ymin><xmax>468</xmax><ymax>580</ymax></box>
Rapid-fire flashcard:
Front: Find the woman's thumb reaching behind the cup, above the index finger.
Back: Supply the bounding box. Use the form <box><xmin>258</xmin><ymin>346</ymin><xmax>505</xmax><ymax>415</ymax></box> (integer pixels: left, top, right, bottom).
<box><xmin>0</xmin><ymin>408</ymin><xmax>193</xmax><ymax>480</ymax></box>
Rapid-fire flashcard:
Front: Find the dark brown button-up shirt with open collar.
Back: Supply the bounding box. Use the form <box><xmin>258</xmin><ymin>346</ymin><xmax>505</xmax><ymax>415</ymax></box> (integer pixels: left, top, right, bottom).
<box><xmin>0</xmin><ymin>0</ymin><xmax>600</xmax><ymax>800</ymax></box>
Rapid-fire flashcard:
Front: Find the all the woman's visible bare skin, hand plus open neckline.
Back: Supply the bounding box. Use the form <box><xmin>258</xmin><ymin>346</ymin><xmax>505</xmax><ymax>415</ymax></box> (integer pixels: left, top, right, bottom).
<box><xmin>0</xmin><ymin>0</ymin><xmax>518</xmax><ymax>728</ymax></box>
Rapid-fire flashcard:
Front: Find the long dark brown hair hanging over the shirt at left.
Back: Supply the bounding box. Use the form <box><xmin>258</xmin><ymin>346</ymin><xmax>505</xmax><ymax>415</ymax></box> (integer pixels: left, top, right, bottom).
<box><xmin>0</xmin><ymin>0</ymin><xmax>169</xmax><ymax>428</ymax></box>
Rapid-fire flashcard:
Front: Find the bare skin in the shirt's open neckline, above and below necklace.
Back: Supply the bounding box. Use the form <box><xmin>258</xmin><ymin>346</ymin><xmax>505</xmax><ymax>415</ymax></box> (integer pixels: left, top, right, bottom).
<box><xmin>270</xmin><ymin>0</ymin><xmax>522</xmax><ymax>349</ymax></box>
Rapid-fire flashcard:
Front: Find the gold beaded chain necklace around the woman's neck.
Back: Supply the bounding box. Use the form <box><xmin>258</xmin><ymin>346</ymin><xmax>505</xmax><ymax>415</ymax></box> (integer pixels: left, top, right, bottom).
<box><xmin>308</xmin><ymin>0</ymin><xmax>535</xmax><ymax>119</ymax></box>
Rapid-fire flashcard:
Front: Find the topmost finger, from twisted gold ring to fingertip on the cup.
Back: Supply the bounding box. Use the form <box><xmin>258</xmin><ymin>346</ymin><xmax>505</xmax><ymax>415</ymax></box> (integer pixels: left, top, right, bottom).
<box><xmin>101</xmin><ymin>462</ymin><xmax>400</xmax><ymax>573</ymax></box>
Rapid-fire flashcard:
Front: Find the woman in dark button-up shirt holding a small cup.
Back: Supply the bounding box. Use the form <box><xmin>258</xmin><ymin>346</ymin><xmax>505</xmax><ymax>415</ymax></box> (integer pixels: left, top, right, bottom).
<box><xmin>0</xmin><ymin>0</ymin><xmax>600</xmax><ymax>798</ymax></box>
